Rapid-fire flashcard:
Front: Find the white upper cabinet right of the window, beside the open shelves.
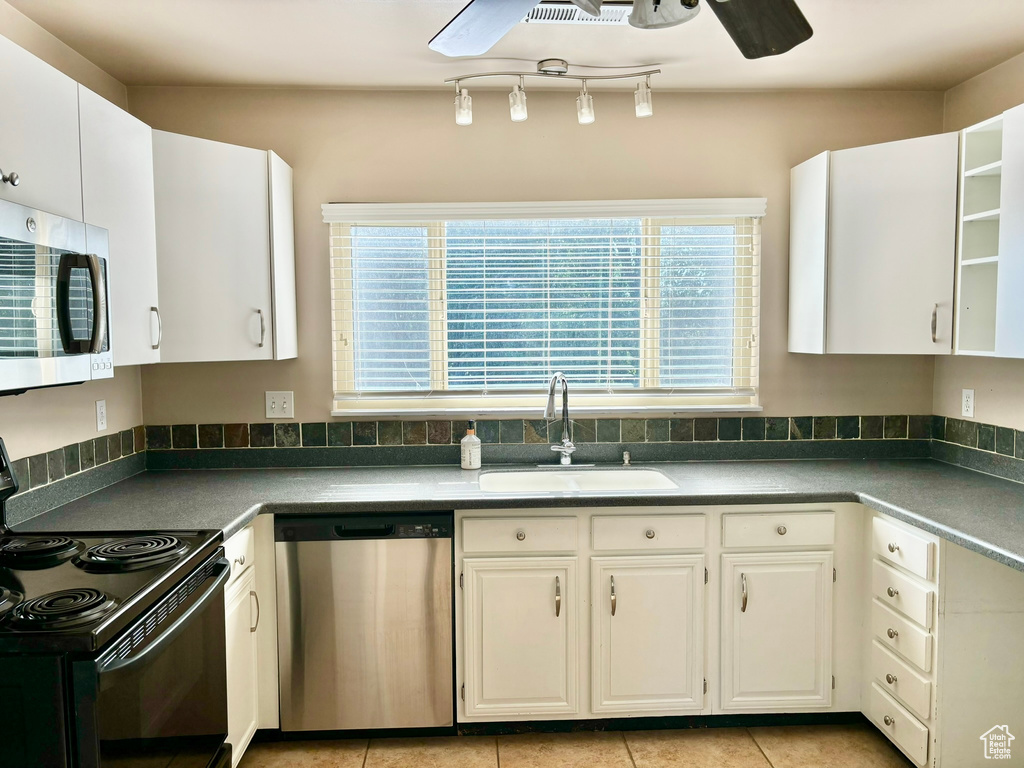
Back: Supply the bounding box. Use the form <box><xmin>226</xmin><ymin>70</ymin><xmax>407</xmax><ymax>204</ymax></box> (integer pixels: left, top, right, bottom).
<box><xmin>790</xmin><ymin>133</ymin><xmax>958</xmax><ymax>354</ymax></box>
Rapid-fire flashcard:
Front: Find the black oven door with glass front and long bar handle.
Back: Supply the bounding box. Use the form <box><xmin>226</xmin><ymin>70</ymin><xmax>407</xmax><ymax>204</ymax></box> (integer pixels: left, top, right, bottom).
<box><xmin>73</xmin><ymin>550</ymin><xmax>230</xmax><ymax>768</ymax></box>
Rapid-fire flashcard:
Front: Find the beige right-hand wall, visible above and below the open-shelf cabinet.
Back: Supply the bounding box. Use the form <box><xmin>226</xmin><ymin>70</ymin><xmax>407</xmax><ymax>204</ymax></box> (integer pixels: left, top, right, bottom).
<box><xmin>933</xmin><ymin>54</ymin><xmax>1024</xmax><ymax>429</ymax></box>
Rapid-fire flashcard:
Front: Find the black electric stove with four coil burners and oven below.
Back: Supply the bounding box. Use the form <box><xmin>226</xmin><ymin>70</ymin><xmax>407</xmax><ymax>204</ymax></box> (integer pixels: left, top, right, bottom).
<box><xmin>0</xmin><ymin>440</ymin><xmax>230</xmax><ymax>768</ymax></box>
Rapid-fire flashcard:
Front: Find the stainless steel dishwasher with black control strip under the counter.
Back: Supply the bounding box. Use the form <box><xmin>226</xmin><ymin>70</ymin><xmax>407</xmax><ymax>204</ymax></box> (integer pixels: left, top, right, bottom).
<box><xmin>274</xmin><ymin>513</ymin><xmax>455</xmax><ymax>731</ymax></box>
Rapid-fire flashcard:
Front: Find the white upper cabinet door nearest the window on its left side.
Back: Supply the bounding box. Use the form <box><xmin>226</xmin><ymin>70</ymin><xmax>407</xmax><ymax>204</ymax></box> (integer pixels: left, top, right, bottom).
<box><xmin>153</xmin><ymin>131</ymin><xmax>273</xmax><ymax>362</ymax></box>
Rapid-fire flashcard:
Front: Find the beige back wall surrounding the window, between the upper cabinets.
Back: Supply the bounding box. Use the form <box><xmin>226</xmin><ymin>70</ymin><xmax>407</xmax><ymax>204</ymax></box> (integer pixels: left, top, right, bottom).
<box><xmin>129</xmin><ymin>87</ymin><xmax>942</xmax><ymax>424</ymax></box>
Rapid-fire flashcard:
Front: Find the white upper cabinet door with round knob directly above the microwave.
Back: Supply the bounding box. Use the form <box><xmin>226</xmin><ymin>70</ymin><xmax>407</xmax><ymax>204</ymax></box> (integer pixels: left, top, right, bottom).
<box><xmin>0</xmin><ymin>36</ymin><xmax>82</xmax><ymax>221</ymax></box>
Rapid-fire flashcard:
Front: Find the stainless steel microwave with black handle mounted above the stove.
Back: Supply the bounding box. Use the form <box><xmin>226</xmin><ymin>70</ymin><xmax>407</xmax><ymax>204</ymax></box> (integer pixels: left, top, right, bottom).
<box><xmin>0</xmin><ymin>201</ymin><xmax>114</xmax><ymax>394</ymax></box>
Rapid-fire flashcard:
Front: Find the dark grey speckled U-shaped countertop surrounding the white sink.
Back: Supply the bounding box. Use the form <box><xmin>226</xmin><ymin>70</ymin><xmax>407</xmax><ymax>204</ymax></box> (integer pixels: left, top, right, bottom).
<box><xmin>16</xmin><ymin>459</ymin><xmax>1024</xmax><ymax>570</ymax></box>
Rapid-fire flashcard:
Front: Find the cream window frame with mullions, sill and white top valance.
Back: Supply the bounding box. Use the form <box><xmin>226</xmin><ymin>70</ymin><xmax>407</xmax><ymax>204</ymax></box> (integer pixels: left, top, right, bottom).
<box><xmin>322</xmin><ymin>198</ymin><xmax>766</xmax><ymax>419</ymax></box>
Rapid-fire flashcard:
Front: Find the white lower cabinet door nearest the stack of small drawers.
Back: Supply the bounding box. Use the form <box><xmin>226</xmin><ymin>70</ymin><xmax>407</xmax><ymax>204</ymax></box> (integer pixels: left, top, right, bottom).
<box><xmin>722</xmin><ymin>552</ymin><xmax>833</xmax><ymax>712</ymax></box>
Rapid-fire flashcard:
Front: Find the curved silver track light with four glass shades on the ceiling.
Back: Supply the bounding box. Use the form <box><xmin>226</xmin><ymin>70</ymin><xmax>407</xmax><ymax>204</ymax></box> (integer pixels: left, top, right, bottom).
<box><xmin>444</xmin><ymin>58</ymin><xmax>662</xmax><ymax>125</ymax></box>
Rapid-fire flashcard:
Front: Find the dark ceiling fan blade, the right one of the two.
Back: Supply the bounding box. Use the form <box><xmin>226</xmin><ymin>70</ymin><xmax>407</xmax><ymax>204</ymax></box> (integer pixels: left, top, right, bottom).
<box><xmin>708</xmin><ymin>0</ymin><xmax>814</xmax><ymax>58</ymax></box>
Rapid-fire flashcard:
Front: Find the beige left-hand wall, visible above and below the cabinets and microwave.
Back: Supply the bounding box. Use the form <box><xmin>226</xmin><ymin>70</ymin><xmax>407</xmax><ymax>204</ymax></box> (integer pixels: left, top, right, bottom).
<box><xmin>0</xmin><ymin>6</ymin><xmax>142</xmax><ymax>459</ymax></box>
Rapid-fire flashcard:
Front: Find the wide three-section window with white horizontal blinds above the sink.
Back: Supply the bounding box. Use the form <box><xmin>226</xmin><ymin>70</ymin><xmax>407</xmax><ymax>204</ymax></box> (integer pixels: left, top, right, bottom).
<box><xmin>325</xmin><ymin>201</ymin><xmax>763</xmax><ymax>414</ymax></box>
